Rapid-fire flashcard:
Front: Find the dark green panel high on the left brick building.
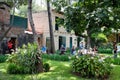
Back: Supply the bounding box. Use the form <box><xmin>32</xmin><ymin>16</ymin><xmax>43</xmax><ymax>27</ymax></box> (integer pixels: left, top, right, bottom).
<box><xmin>10</xmin><ymin>15</ymin><xmax>27</xmax><ymax>29</ymax></box>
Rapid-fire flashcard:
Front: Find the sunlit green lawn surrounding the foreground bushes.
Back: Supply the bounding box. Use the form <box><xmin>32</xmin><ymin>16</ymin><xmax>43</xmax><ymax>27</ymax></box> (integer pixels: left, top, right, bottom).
<box><xmin>0</xmin><ymin>60</ymin><xmax>120</xmax><ymax>80</ymax></box>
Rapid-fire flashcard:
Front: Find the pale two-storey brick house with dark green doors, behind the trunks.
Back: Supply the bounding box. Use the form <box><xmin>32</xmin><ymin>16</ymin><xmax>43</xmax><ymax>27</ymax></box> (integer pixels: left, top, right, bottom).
<box><xmin>28</xmin><ymin>10</ymin><xmax>78</xmax><ymax>50</ymax></box>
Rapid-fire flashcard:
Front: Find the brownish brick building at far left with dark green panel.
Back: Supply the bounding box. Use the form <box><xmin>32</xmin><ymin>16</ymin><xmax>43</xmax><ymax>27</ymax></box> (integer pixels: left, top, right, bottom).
<box><xmin>0</xmin><ymin>2</ymin><xmax>27</xmax><ymax>53</ymax></box>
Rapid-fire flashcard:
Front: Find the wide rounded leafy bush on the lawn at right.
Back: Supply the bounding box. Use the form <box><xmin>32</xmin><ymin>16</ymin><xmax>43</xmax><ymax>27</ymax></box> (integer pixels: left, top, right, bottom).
<box><xmin>72</xmin><ymin>55</ymin><xmax>112</xmax><ymax>79</ymax></box>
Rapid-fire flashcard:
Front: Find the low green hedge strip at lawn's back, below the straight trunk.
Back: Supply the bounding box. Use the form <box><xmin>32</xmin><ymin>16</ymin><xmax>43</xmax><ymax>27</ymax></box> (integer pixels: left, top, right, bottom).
<box><xmin>42</xmin><ymin>54</ymin><xmax>69</xmax><ymax>61</ymax></box>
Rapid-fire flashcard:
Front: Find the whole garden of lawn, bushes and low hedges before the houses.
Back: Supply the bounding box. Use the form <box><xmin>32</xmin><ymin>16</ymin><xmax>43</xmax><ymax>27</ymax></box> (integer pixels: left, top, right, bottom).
<box><xmin>0</xmin><ymin>44</ymin><xmax>120</xmax><ymax>80</ymax></box>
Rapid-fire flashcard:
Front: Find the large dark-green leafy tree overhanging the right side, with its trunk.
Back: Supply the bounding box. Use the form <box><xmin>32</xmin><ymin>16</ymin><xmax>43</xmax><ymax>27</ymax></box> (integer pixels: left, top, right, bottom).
<box><xmin>54</xmin><ymin>0</ymin><xmax>120</xmax><ymax>48</ymax></box>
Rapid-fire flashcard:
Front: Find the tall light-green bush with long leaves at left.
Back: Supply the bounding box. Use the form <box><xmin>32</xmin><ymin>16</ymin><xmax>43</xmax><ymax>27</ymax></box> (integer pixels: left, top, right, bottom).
<box><xmin>7</xmin><ymin>44</ymin><xmax>41</xmax><ymax>73</ymax></box>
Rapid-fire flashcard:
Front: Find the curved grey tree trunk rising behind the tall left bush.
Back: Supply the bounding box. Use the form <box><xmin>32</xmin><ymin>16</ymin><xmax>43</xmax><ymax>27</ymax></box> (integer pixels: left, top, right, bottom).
<box><xmin>28</xmin><ymin>0</ymin><xmax>43</xmax><ymax>72</ymax></box>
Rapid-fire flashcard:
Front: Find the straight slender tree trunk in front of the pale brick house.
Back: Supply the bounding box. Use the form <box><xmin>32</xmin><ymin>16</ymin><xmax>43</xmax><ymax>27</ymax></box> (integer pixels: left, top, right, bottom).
<box><xmin>47</xmin><ymin>0</ymin><xmax>55</xmax><ymax>53</ymax></box>
